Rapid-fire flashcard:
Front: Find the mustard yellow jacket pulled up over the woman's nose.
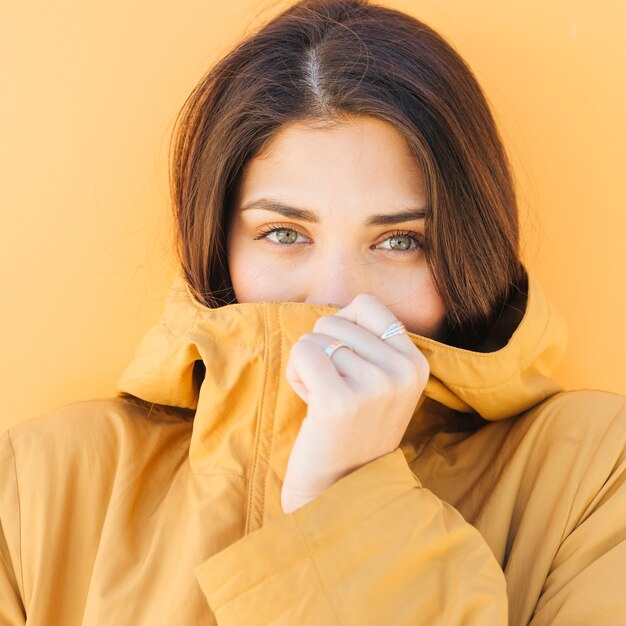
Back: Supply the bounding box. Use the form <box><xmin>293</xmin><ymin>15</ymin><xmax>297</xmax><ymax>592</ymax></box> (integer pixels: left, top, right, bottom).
<box><xmin>0</xmin><ymin>276</ymin><xmax>626</xmax><ymax>626</ymax></box>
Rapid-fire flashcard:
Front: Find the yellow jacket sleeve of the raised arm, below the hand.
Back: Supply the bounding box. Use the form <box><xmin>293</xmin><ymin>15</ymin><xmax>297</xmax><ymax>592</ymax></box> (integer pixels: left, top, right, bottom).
<box><xmin>194</xmin><ymin>448</ymin><xmax>508</xmax><ymax>626</ymax></box>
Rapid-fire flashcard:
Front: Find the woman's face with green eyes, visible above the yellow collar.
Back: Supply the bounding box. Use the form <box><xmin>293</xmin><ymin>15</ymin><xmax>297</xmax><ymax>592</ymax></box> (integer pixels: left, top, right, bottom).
<box><xmin>228</xmin><ymin>112</ymin><xmax>445</xmax><ymax>338</ymax></box>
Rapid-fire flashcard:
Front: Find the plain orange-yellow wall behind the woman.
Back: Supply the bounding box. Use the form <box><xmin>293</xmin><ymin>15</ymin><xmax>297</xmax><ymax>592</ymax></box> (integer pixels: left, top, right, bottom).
<box><xmin>0</xmin><ymin>0</ymin><xmax>626</xmax><ymax>430</ymax></box>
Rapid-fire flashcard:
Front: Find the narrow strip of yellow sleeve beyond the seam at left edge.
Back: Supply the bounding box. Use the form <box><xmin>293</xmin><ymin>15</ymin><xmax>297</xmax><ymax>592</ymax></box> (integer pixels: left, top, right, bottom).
<box><xmin>0</xmin><ymin>431</ymin><xmax>26</xmax><ymax>626</ymax></box>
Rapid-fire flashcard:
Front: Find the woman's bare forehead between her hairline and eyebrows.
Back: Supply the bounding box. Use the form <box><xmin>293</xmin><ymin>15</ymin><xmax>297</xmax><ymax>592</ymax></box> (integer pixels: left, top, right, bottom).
<box><xmin>234</xmin><ymin>118</ymin><xmax>425</xmax><ymax>213</ymax></box>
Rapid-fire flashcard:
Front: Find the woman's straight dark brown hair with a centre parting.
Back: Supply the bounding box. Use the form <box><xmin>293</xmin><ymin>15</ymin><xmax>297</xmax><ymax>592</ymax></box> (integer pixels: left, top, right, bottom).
<box><xmin>170</xmin><ymin>0</ymin><xmax>527</xmax><ymax>351</ymax></box>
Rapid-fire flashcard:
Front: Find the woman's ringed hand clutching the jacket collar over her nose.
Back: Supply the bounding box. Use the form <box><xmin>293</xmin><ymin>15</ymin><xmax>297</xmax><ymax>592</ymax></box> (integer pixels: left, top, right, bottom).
<box><xmin>281</xmin><ymin>293</ymin><xmax>430</xmax><ymax>513</ymax></box>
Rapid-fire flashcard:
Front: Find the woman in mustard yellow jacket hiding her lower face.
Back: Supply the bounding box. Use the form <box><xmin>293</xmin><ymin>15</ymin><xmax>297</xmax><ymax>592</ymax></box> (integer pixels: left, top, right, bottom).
<box><xmin>0</xmin><ymin>0</ymin><xmax>626</xmax><ymax>626</ymax></box>
